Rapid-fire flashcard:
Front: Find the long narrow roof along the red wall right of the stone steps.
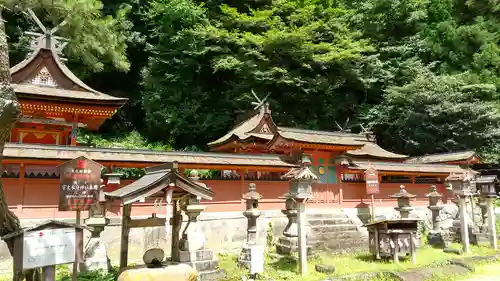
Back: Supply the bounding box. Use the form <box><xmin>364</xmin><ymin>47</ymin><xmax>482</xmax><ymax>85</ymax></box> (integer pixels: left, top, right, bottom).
<box><xmin>348</xmin><ymin>160</ymin><xmax>469</xmax><ymax>174</ymax></box>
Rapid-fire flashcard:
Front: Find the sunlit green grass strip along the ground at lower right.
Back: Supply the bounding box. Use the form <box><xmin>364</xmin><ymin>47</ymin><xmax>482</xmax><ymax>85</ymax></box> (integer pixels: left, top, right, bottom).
<box><xmin>220</xmin><ymin>244</ymin><xmax>498</xmax><ymax>281</ymax></box>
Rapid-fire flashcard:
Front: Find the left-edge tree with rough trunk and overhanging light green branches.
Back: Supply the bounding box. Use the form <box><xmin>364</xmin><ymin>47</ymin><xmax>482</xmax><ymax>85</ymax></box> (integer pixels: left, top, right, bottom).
<box><xmin>0</xmin><ymin>0</ymin><xmax>131</xmax><ymax>280</ymax></box>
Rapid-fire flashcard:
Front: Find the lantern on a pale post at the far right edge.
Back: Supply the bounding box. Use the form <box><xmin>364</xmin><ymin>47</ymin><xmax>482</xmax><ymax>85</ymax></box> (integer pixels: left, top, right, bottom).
<box><xmin>476</xmin><ymin>175</ymin><xmax>499</xmax><ymax>249</ymax></box>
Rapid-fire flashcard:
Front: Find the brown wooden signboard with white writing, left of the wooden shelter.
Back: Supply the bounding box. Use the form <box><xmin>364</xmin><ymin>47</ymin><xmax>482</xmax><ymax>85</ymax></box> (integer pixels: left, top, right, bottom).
<box><xmin>59</xmin><ymin>156</ymin><xmax>102</xmax><ymax>211</ymax></box>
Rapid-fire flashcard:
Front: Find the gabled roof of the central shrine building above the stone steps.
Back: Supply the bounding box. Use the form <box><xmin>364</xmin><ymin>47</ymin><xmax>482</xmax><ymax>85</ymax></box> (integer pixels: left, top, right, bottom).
<box><xmin>208</xmin><ymin>105</ymin><xmax>408</xmax><ymax>160</ymax></box>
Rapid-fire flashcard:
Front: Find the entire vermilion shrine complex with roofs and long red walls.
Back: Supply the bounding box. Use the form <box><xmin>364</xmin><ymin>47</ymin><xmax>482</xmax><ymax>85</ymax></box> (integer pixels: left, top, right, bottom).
<box><xmin>3</xmin><ymin>30</ymin><xmax>480</xmax><ymax>219</ymax></box>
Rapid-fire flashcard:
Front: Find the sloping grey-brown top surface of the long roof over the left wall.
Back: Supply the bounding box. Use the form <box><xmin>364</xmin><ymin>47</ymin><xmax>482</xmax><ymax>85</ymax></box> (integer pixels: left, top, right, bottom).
<box><xmin>3</xmin><ymin>143</ymin><xmax>297</xmax><ymax>168</ymax></box>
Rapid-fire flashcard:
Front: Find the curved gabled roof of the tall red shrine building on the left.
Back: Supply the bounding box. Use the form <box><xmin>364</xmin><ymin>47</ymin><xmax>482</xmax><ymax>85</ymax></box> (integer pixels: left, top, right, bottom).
<box><xmin>10</xmin><ymin>48</ymin><xmax>128</xmax><ymax>106</ymax></box>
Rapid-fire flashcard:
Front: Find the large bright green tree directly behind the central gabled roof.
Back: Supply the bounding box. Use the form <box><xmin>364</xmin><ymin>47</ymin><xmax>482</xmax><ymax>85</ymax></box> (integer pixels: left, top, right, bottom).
<box><xmin>142</xmin><ymin>0</ymin><xmax>382</xmax><ymax>147</ymax></box>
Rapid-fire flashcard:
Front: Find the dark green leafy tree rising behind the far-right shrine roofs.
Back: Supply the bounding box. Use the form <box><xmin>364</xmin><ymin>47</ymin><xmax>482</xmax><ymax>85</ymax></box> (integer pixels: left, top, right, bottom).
<box><xmin>363</xmin><ymin>65</ymin><xmax>500</xmax><ymax>161</ymax></box>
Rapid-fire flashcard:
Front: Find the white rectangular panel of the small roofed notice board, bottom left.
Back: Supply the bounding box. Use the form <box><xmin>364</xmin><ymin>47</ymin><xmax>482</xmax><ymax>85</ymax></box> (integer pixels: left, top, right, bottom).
<box><xmin>23</xmin><ymin>228</ymin><xmax>76</xmax><ymax>269</ymax></box>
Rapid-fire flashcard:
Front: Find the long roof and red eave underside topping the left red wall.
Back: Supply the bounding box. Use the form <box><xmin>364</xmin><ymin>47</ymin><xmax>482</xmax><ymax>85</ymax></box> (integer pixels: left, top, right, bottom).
<box><xmin>3</xmin><ymin>143</ymin><xmax>298</xmax><ymax>171</ymax></box>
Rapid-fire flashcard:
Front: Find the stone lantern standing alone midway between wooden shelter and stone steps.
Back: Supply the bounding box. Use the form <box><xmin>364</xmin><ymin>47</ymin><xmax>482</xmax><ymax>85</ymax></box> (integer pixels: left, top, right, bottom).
<box><xmin>238</xmin><ymin>183</ymin><xmax>262</xmax><ymax>269</ymax></box>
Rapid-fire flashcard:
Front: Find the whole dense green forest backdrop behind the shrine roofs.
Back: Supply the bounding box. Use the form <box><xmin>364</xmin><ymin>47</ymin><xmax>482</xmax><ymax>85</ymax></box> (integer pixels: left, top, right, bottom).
<box><xmin>3</xmin><ymin>0</ymin><xmax>500</xmax><ymax>162</ymax></box>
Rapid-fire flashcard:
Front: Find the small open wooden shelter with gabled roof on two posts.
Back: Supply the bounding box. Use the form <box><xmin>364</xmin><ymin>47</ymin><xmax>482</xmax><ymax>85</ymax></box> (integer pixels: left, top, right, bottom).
<box><xmin>105</xmin><ymin>162</ymin><xmax>214</xmax><ymax>269</ymax></box>
